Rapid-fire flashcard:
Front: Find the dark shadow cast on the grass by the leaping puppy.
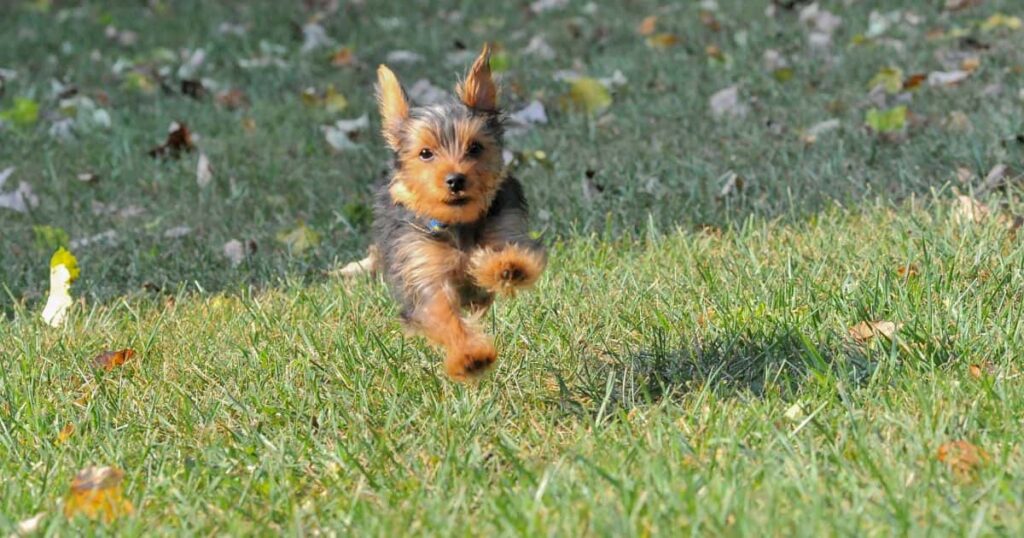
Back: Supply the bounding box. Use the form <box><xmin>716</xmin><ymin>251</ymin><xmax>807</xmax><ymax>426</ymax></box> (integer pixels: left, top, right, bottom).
<box><xmin>557</xmin><ymin>326</ymin><xmax>874</xmax><ymax>415</ymax></box>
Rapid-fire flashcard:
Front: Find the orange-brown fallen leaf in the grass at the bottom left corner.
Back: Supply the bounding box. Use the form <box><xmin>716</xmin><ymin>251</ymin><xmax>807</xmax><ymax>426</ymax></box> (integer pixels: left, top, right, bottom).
<box><xmin>65</xmin><ymin>466</ymin><xmax>135</xmax><ymax>523</ymax></box>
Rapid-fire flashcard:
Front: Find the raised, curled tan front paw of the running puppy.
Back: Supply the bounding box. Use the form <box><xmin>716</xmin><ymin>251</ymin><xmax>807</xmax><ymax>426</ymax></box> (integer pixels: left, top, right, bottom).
<box><xmin>470</xmin><ymin>245</ymin><xmax>545</xmax><ymax>295</ymax></box>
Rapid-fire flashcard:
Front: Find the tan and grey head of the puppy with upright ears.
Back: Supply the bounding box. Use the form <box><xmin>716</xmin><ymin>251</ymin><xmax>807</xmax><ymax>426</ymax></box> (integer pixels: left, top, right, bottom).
<box><xmin>377</xmin><ymin>45</ymin><xmax>504</xmax><ymax>223</ymax></box>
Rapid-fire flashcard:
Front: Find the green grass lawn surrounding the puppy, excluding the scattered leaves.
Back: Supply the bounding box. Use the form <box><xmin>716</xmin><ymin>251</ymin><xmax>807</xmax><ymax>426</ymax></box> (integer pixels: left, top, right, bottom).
<box><xmin>0</xmin><ymin>0</ymin><xmax>1024</xmax><ymax>536</ymax></box>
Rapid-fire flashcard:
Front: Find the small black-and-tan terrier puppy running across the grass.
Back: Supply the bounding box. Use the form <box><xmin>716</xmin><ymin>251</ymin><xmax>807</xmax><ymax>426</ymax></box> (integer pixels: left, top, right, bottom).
<box><xmin>350</xmin><ymin>45</ymin><xmax>547</xmax><ymax>380</ymax></box>
